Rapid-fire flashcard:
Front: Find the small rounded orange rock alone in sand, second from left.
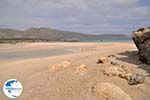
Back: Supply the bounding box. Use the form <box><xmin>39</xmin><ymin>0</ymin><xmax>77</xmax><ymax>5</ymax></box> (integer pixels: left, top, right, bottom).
<box><xmin>75</xmin><ymin>64</ymin><xmax>88</xmax><ymax>75</ymax></box>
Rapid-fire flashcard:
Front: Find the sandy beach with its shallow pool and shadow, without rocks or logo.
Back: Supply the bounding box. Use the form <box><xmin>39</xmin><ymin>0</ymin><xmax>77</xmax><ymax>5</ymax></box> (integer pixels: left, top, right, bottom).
<box><xmin>0</xmin><ymin>42</ymin><xmax>150</xmax><ymax>100</ymax></box>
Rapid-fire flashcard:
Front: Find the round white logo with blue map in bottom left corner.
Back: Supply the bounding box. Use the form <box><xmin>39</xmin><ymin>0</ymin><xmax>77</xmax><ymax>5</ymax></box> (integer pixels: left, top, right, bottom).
<box><xmin>3</xmin><ymin>79</ymin><xmax>23</xmax><ymax>98</ymax></box>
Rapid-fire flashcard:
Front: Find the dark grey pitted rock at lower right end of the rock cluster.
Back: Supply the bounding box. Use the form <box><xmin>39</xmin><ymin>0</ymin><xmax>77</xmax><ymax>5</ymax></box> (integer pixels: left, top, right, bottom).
<box><xmin>127</xmin><ymin>74</ymin><xmax>145</xmax><ymax>85</ymax></box>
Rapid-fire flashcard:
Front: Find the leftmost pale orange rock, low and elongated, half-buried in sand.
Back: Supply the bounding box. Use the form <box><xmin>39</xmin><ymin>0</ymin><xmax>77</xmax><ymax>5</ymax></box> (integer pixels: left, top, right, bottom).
<box><xmin>50</xmin><ymin>61</ymin><xmax>71</xmax><ymax>71</ymax></box>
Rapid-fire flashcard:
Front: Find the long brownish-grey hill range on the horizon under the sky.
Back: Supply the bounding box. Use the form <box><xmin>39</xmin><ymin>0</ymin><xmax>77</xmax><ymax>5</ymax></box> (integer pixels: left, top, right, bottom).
<box><xmin>0</xmin><ymin>28</ymin><xmax>128</xmax><ymax>41</ymax></box>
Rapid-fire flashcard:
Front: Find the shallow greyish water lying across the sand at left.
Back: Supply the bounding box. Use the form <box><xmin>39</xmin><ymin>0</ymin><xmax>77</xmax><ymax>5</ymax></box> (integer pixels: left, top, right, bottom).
<box><xmin>0</xmin><ymin>48</ymin><xmax>73</xmax><ymax>60</ymax></box>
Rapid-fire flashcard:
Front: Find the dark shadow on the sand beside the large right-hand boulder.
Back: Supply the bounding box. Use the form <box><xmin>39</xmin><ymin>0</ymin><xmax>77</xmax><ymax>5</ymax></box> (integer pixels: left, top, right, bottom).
<box><xmin>116</xmin><ymin>51</ymin><xmax>150</xmax><ymax>77</ymax></box>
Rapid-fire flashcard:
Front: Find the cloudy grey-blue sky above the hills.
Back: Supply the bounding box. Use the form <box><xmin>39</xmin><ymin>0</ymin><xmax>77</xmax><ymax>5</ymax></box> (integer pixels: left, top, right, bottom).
<box><xmin>0</xmin><ymin>0</ymin><xmax>150</xmax><ymax>34</ymax></box>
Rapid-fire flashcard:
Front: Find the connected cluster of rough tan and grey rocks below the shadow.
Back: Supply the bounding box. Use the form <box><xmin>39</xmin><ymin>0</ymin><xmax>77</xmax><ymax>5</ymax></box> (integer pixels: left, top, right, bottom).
<box><xmin>97</xmin><ymin>55</ymin><xmax>145</xmax><ymax>85</ymax></box>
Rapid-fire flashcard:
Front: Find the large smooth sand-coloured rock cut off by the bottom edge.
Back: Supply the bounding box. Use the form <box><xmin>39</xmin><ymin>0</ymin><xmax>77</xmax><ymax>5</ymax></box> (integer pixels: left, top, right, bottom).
<box><xmin>93</xmin><ymin>82</ymin><xmax>132</xmax><ymax>100</ymax></box>
